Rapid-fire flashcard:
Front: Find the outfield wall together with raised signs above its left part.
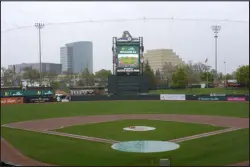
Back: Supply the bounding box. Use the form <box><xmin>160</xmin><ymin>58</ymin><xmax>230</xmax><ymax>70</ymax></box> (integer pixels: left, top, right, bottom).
<box><xmin>1</xmin><ymin>88</ymin><xmax>249</xmax><ymax>105</ymax></box>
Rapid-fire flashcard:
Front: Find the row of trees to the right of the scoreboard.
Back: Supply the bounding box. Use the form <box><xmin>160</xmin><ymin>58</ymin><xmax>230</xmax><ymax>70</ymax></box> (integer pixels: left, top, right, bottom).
<box><xmin>144</xmin><ymin>61</ymin><xmax>249</xmax><ymax>88</ymax></box>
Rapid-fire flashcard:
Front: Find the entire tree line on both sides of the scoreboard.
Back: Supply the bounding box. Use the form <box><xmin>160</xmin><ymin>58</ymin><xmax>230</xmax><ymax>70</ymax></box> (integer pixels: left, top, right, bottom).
<box><xmin>1</xmin><ymin>61</ymin><xmax>249</xmax><ymax>88</ymax></box>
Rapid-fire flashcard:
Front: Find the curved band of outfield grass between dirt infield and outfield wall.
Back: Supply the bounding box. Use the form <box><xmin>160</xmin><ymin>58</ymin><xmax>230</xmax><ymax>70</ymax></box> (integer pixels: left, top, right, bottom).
<box><xmin>1</xmin><ymin>101</ymin><xmax>249</xmax><ymax>124</ymax></box>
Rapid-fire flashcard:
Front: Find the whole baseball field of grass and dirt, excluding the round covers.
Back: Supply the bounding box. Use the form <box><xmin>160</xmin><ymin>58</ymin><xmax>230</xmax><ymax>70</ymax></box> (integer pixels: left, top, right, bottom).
<box><xmin>1</xmin><ymin>101</ymin><xmax>249</xmax><ymax>166</ymax></box>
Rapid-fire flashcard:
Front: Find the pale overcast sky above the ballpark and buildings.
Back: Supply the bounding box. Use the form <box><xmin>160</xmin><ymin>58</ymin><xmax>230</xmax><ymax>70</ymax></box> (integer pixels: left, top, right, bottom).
<box><xmin>1</xmin><ymin>1</ymin><xmax>249</xmax><ymax>72</ymax></box>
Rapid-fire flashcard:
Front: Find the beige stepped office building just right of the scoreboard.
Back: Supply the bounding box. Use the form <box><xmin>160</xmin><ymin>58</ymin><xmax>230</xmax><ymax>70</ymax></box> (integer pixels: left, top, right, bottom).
<box><xmin>144</xmin><ymin>49</ymin><xmax>184</xmax><ymax>71</ymax></box>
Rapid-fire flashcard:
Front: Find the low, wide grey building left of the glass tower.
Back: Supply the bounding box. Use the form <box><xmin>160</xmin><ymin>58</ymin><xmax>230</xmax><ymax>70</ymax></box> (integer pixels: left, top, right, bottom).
<box><xmin>8</xmin><ymin>63</ymin><xmax>62</xmax><ymax>74</ymax></box>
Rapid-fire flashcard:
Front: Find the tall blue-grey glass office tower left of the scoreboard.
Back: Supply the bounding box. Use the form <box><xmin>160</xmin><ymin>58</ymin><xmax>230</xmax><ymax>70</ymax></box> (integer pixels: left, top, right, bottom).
<box><xmin>60</xmin><ymin>41</ymin><xmax>93</xmax><ymax>73</ymax></box>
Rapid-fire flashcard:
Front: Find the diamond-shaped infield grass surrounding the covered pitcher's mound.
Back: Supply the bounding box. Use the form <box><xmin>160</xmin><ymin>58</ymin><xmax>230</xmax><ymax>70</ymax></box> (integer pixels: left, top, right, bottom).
<box><xmin>56</xmin><ymin>120</ymin><xmax>225</xmax><ymax>141</ymax></box>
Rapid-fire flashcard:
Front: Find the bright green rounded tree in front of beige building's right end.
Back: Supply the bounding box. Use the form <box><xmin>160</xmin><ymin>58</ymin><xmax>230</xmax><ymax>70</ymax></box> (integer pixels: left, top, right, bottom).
<box><xmin>172</xmin><ymin>67</ymin><xmax>188</xmax><ymax>88</ymax></box>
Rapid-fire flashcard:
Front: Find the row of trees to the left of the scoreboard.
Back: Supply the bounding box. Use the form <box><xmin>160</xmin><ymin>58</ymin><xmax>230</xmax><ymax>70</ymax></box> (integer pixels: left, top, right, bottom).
<box><xmin>1</xmin><ymin>67</ymin><xmax>112</xmax><ymax>87</ymax></box>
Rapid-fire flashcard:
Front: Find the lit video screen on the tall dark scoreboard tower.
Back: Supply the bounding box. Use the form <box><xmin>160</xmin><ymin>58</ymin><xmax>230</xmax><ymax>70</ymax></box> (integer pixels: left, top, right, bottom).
<box><xmin>116</xmin><ymin>45</ymin><xmax>140</xmax><ymax>72</ymax></box>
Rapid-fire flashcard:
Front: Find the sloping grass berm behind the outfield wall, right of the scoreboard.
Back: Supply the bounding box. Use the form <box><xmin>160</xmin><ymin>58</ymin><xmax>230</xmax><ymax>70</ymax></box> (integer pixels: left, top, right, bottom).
<box><xmin>150</xmin><ymin>88</ymin><xmax>249</xmax><ymax>94</ymax></box>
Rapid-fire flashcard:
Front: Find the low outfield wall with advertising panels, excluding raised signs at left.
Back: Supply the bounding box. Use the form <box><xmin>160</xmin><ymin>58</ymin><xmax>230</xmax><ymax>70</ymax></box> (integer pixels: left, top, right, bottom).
<box><xmin>1</xmin><ymin>94</ymin><xmax>249</xmax><ymax>105</ymax></box>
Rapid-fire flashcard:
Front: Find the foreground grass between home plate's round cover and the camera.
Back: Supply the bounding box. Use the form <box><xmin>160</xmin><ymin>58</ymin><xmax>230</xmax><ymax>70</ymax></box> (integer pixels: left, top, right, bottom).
<box><xmin>2</xmin><ymin>127</ymin><xmax>249</xmax><ymax>166</ymax></box>
